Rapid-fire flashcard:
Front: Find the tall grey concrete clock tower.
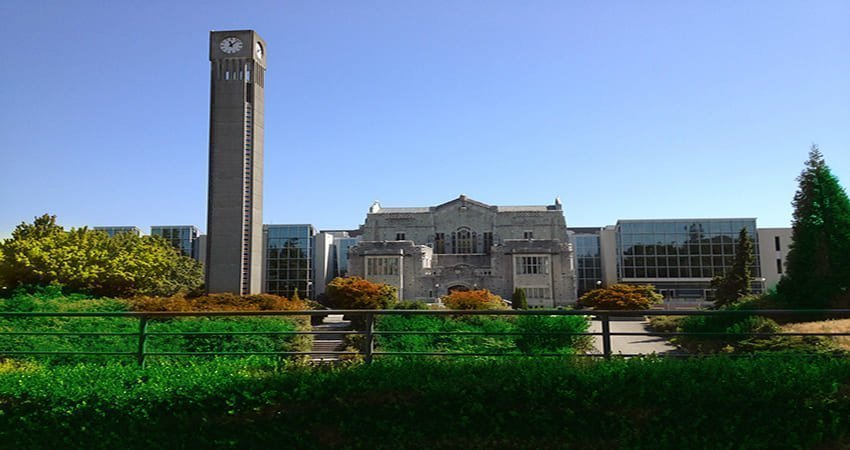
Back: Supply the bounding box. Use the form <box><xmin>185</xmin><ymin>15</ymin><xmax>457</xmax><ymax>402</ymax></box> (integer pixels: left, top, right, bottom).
<box><xmin>206</xmin><ymin>30</ymin><xmax>266</xmax><ymax>295</ymax></box>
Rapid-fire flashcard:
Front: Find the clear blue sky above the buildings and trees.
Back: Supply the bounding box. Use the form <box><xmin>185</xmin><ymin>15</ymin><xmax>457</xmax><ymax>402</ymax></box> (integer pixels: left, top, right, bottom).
<box><xmin>0</xmin><ymin>0</ymin><xmax>850</xmax><ymax>237</ymax></box>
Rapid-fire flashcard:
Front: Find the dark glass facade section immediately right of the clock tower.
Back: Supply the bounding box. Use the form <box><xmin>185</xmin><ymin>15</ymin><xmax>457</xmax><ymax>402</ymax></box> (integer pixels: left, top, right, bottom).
<box><xmin>263</xmin><ymin>225</ymin><xmax>316</xmax><ymax>298</ymax></box>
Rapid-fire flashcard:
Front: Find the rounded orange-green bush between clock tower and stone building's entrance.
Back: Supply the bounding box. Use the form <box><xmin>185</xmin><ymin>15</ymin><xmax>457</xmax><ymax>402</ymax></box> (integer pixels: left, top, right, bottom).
<box><xmin>325</xmin><ymin>277</ymin><xmax>398</xmax><ymax>309</ymax></box>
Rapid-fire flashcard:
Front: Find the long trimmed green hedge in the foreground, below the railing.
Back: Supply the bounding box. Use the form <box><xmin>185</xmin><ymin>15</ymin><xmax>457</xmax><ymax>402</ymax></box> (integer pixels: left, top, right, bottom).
<box><xmin>0</xmin><ymin>355</ymin><xmax>850</xmax><ymax>449</ymax></box>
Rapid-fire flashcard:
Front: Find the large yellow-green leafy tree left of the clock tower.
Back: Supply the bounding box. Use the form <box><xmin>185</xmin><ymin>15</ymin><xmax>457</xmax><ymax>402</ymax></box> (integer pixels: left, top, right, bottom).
<box><xmin>0</xmin><ymin>214</ymin><xmax>203</xmax><ymax>297</ymax></box>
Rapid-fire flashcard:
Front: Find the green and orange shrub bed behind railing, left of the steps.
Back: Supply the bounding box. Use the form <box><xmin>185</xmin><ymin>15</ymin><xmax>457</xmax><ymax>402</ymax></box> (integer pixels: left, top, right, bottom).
<box><xmin>0</xmin><ymin>287</ymin><xmax>312</xmax><ymax>365</ymax></box>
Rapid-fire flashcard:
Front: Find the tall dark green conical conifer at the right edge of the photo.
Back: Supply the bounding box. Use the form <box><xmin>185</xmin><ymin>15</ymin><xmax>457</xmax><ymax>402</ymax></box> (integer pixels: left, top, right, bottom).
<box><xmin>777</xmin><ymin>145</ymin><xmax>850</xmax><ymax>307</ymax></box>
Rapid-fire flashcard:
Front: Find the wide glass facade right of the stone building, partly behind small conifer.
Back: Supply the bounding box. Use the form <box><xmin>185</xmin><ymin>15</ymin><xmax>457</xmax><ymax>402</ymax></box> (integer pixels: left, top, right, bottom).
<box><xmin>616</xmin><ymin>219</ymin><xmax>763</xmax><ymax>299</ymax></box>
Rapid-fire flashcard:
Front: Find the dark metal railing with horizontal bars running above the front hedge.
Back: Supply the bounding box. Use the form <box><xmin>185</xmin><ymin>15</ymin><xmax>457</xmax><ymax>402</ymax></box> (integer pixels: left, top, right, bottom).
<box><xmin>0</xmin><ymin>309</ymin><xmax>850</xmax><ymax>366</ymax></box>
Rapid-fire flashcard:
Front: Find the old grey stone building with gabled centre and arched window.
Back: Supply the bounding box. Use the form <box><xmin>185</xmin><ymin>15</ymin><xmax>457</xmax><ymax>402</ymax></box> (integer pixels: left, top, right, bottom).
<box><xmin>348</xmin><ymin>195</ymin><xmax>576</xmax><ymax>307</ymax></box>
